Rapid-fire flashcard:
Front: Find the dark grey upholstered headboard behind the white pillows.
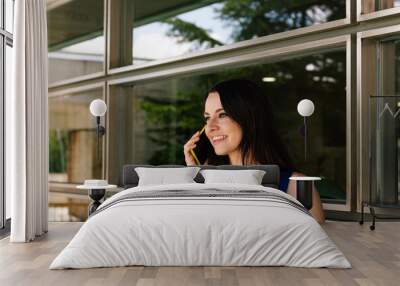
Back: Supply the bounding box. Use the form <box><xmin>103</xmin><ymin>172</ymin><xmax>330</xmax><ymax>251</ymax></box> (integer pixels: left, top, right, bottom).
<box><xmin>122</xmin><ymin>165</ymin><xmax>280</xmax><ymax>189</ymax></box>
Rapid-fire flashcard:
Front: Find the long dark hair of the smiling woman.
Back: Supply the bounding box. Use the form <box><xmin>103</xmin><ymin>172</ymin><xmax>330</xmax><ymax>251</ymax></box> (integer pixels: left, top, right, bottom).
<box><xmin>203</xmin><ymin>79</ymin><xmax>293</xmax><ymax>168</ymax></box>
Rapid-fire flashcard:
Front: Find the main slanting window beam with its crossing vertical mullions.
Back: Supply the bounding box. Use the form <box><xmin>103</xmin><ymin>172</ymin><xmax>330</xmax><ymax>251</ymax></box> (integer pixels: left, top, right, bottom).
<box><xmin>49</xmin><ymin>0</ymin><xmax>400</xmax><ymax>216</ymax></box>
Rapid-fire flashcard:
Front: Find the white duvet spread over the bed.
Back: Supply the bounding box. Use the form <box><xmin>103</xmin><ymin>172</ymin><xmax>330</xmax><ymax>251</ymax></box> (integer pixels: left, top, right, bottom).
<box><xmin>50</xmin><ymin>183</ymin><xmax>351</xmax><ymax>269</ymax></box>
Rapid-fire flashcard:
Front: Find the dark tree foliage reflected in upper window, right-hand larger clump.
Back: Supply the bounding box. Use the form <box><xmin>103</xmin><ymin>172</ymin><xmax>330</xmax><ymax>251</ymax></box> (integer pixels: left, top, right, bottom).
<box><xmin>217</xmin><ymin>0</ymin><xmax>346</xmax><ymax>41</ymax></box>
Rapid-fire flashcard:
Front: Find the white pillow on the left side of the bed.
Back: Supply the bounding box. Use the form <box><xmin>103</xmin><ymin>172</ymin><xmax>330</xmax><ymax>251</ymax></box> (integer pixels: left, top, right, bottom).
<box><xmin>135</xmin><ymin>167</ymin><xmax>200</xmax><ymax>186</ymax></box>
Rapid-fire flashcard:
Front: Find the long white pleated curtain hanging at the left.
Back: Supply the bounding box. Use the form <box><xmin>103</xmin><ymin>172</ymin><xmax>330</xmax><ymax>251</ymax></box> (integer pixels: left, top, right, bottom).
<box><xmin>6</xmin><ymin>0</ymin><xmax>48</xmax><ymax>242</ymax></box>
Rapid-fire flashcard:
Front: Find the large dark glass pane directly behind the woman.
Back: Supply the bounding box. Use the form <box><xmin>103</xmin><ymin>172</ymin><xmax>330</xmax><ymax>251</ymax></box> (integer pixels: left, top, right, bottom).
<box><xmin>110</xmin><ymin>50</ymin><xmax>346</xmax><ymax>203</ymax></box>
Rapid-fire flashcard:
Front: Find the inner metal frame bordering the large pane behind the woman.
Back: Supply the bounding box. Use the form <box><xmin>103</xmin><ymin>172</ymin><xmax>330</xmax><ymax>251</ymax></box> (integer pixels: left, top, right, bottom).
<box><xmin>102</xmin><ymin>35</ymin><xmax>355</xmax><ymax>211</ymax></box>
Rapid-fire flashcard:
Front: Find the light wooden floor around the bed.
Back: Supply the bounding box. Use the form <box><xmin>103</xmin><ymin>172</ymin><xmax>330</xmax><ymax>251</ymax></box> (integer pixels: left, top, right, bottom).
<box><xmin>0</xmin><ymin>221</ymin><xmax>400</xmax><ymax>286</ymax></box>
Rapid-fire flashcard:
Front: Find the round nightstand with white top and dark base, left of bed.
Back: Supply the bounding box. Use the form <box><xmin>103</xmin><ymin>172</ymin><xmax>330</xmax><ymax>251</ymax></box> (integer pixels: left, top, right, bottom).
<box><xmin>76</xmin><ymin>180</ymin><xmax>117</xmax><ymax>216</ymax></box>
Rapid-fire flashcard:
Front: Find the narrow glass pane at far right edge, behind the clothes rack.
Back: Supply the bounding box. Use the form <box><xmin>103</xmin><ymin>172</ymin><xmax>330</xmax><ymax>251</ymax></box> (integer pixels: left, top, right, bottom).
<box><xmin>370</xmin><ymin>37</ymin><xmax>400</xmax><ymax>205</ymax></box>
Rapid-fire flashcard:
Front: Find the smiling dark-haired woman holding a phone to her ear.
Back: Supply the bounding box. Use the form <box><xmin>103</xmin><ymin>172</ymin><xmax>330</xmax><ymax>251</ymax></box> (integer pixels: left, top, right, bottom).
<box><xmin>183</xmin><ymin>79</ymin><xmax>325</xmax><ymax>223</ymax></box>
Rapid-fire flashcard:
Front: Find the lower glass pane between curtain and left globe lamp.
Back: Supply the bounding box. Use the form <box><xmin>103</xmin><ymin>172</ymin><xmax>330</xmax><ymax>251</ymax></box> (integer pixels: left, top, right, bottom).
<box><xmin>49</xmin><ymin>89</ymin><xmax>102</xmax><ymax>183</ymax></box>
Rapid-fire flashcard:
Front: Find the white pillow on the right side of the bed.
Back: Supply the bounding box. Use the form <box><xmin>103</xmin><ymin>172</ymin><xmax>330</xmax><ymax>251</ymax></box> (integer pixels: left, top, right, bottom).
<box><xmin>200</xmin><ymin>169</ymin><xmax>265</xmax><ymax>185</ymax></box>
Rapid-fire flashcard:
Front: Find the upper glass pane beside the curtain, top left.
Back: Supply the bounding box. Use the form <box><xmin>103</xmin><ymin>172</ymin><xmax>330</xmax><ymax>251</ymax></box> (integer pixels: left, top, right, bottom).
<box><xmin>47</xmin><ymin>0</ymin><xmax>105</xmax><ymax>84</ymax></box>
